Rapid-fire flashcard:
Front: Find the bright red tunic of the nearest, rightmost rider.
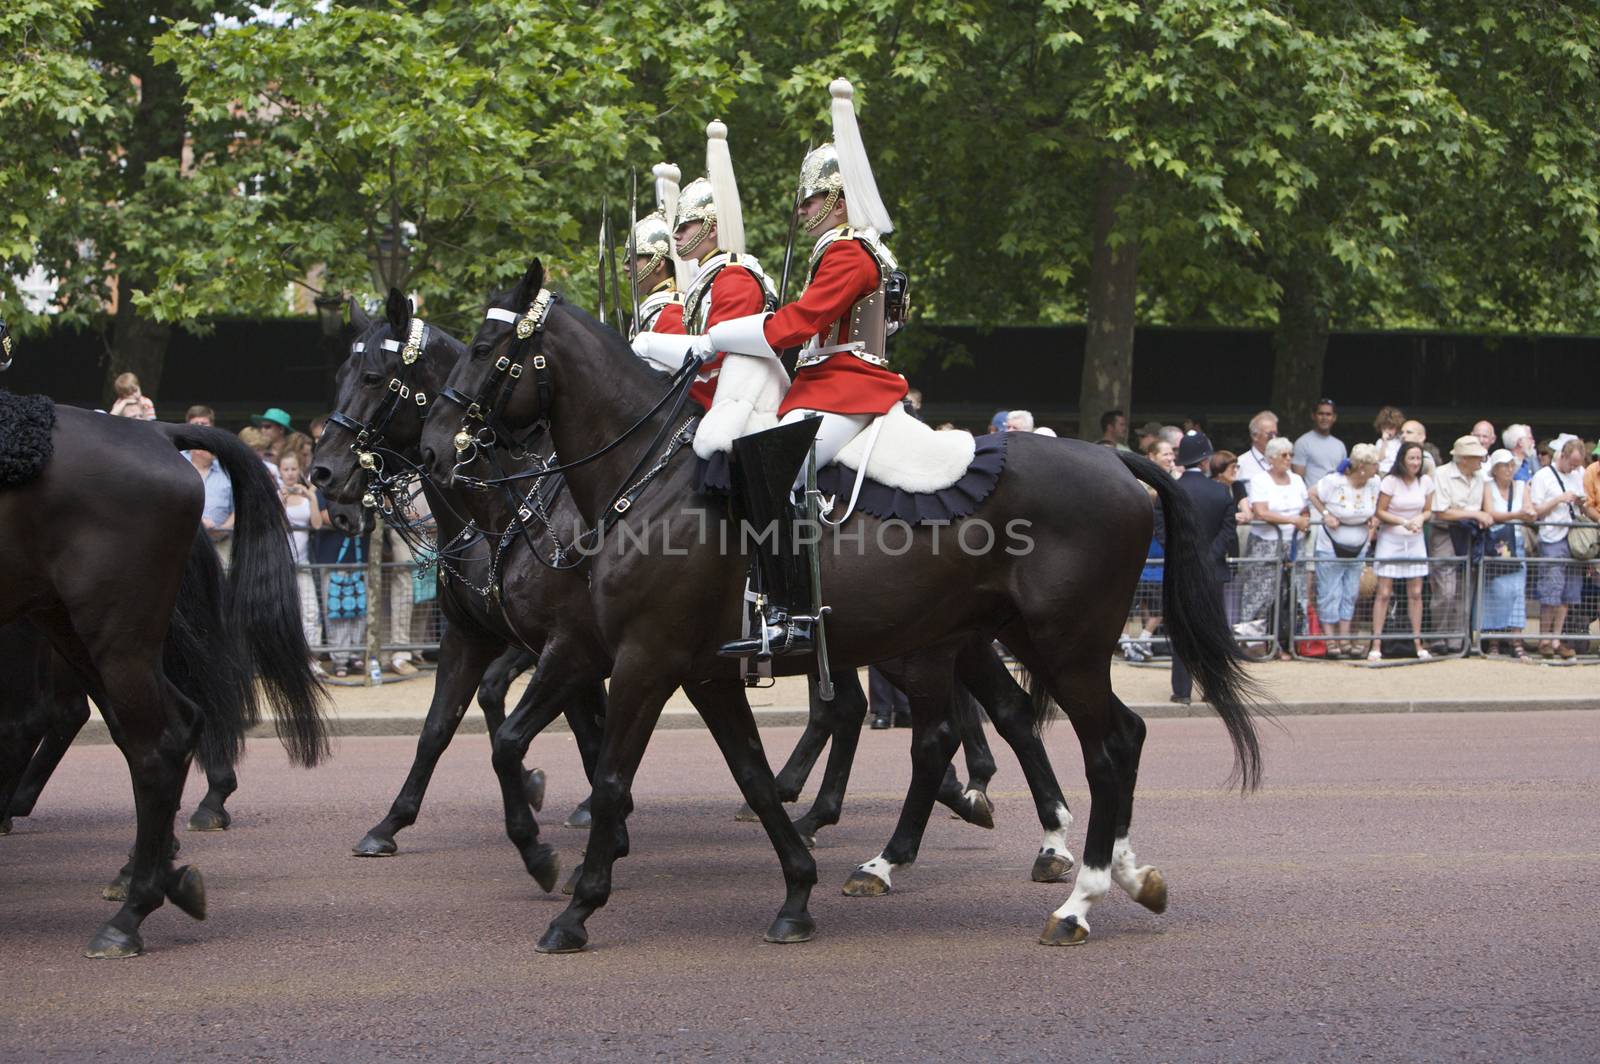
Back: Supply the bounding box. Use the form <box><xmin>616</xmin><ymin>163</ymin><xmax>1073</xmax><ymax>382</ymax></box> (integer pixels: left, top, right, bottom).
<box><xmin>766</xmin><ymin>240</ymin><xmax>907</xmax><ymax>418</ymax></box>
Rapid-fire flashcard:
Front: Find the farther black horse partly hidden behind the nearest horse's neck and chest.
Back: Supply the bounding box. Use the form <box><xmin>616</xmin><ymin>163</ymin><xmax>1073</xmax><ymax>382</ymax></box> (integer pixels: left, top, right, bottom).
<box><xmin>310</xmin><ymin>291</ymin><xmax>610</xmax><ymax>890</ymax></box>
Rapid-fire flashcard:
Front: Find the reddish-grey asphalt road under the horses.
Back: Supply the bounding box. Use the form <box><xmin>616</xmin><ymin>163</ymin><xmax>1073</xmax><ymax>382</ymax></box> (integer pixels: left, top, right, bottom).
<box><xmin>0</xmin><ymin>712</ymin><xmax>1600</xmax><ymax>1062</ymax></box>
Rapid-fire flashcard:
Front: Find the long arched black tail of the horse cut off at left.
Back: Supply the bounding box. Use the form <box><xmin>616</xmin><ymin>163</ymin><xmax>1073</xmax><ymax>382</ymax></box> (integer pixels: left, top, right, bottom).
<box><xmin>160</xmin><ymin>424</ymin><xmax>328</xmax><ymax>766</ymax></box>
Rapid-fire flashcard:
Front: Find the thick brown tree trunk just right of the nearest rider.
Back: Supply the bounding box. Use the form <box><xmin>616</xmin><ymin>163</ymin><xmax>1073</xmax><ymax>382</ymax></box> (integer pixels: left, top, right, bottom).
<box><xmin>1078</xmin><ymin>160</ymin><xmax>1139</xmax><ymax>440</ymax></box>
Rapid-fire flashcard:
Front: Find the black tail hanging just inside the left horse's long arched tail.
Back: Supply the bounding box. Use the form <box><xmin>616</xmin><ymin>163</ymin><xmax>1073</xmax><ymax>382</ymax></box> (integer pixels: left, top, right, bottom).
<box><xmin>162</xmin><ymin>528</ymin><xmax>258</xmax><ymax>771</ymax></box>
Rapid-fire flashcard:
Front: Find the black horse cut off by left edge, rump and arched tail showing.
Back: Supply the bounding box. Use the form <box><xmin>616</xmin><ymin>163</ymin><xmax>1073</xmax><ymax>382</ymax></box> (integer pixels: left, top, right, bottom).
<box><xmin>0</xmin><ymin>406</ymin><xmax>326</xmax><ymax>957</ymax></box>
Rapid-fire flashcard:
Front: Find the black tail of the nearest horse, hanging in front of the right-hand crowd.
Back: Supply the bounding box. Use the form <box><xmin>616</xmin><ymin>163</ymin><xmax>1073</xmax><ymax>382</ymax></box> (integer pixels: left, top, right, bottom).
<box><xmin>1117</xmin><ymin>451</ymin><xmax>1270</xmax><ymax>790</ymax></box>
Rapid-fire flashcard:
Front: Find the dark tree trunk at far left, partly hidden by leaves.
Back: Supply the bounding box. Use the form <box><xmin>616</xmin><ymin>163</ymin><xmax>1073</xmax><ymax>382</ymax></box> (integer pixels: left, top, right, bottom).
<box><xmin>104</xmin><ymin>33</ymin><xmax>187</xmax><ymax>408</ymax></box>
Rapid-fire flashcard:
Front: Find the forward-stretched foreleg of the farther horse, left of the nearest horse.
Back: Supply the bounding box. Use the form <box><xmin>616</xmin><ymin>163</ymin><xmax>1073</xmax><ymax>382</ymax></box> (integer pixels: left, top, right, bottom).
<box><xmin>354</xmin><ymin>622</ymin><xmax>499</xmax><ymax>858</ymax></box>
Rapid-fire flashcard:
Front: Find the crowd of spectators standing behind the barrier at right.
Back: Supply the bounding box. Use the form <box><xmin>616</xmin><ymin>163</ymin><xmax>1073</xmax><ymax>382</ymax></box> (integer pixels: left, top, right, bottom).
<box><xmin>1096</xmin><ymin>398</ymin><xmax>1600</xmax><ymax>661</ymax></box>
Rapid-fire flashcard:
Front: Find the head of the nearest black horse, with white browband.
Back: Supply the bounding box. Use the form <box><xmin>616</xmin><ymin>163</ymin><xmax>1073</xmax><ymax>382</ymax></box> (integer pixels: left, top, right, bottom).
<box><xmin>422</xmin><ymin>259</ymin><xmax>555</xmax><ymax>483</ymax></box>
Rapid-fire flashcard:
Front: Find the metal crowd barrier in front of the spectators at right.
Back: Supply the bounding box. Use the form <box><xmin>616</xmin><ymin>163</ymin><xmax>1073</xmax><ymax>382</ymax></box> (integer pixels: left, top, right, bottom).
<box><xmin>1118</xmin><ymin>522</ymin><xmax>1600</xmax><ymax>664</ymax></box>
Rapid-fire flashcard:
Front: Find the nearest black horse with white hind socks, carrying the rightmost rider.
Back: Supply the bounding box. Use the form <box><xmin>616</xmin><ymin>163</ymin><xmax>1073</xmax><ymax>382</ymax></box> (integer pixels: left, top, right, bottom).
<box><xmin>422</xmin><ymin>262</ymin><xmax>1259</xmax><ymax>952</ymax></box>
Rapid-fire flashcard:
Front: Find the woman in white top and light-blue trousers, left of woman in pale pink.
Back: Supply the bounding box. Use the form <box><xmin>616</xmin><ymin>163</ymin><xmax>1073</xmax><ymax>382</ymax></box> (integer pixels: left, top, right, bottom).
<box><xmin>1310</xmin><ymin>443</ymin><xmax>1378</xmax><ymax>658</ymax></box>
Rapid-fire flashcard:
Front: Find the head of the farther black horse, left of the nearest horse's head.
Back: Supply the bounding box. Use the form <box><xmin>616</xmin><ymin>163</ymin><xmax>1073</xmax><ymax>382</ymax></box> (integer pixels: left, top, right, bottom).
<box><xmin>310</xmin><ymin>290</ymin><xmax>461</xmax><ymax>533</ymax></box>
